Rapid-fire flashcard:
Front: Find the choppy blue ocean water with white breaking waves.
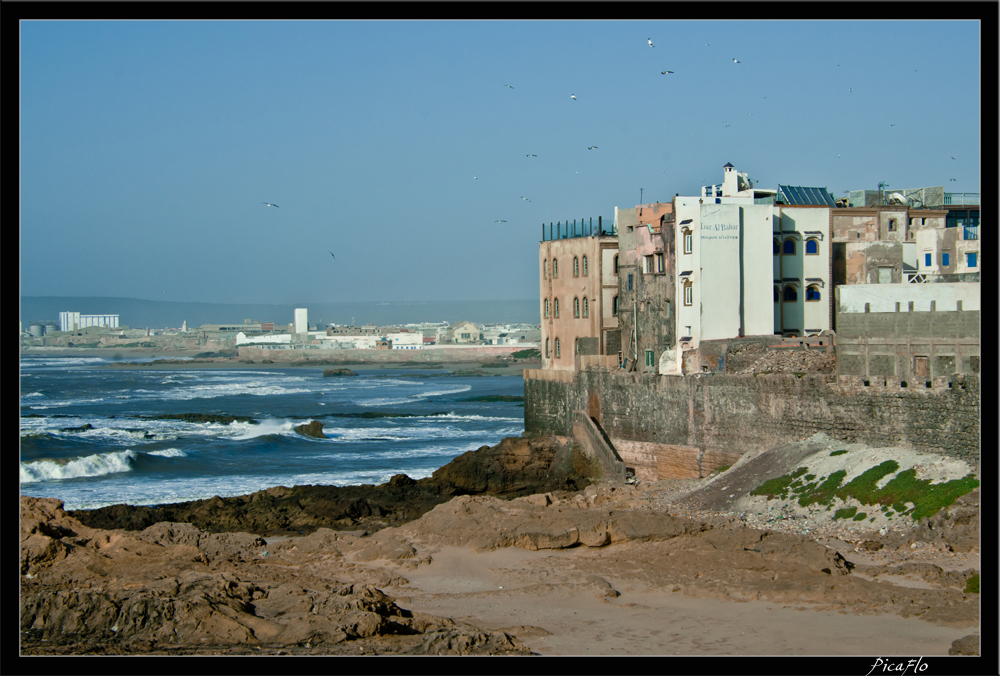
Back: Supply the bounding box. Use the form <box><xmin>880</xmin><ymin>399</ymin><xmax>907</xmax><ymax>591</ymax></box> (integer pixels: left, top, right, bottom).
<box><xmin>20</xmin><ymin>356</ymin><xmax>524</xmax><ymax>509</ymax></box>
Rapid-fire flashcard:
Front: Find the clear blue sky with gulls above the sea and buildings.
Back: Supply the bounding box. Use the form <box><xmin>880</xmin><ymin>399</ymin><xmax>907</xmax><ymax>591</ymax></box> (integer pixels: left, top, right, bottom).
<box><xmin>20</xmin><ymin>21</ymin><xmax>981</xmax><ymax>303</ymax></box>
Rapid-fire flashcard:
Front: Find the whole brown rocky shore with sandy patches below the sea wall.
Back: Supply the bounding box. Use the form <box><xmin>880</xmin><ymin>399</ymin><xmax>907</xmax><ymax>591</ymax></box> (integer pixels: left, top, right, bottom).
<box><xmin>20</xmin><ymin>438</ymin><xmax>980</xmax><ymax>656</ymax></box>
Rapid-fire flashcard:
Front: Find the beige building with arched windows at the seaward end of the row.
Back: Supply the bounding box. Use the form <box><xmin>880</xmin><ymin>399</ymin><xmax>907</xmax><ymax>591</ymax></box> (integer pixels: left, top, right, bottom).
<box><xmin>538</xmin><ymin>220</ymin><xmax>619</xmax><ymax>371</ymax></box>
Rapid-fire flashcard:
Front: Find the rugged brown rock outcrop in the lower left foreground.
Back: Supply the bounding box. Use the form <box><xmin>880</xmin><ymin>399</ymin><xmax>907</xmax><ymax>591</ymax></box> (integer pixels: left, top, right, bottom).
<box><xmin>21</xmin><ymin>497</ymin><xmax>527</xmax><ymax>654</ymax></box>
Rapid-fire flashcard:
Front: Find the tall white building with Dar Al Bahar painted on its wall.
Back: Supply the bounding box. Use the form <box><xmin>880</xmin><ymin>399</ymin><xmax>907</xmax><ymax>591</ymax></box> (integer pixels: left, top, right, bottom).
<box><xmin>676</xmin><ymin>164</ymin><xmax>832</xmax><ymax>373</ymax></box>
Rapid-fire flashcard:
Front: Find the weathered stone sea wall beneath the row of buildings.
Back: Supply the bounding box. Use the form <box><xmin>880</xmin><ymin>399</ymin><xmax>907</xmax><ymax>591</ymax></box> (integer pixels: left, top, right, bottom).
<box><xmin>524</xmin><ymin>369</ymin><xmax>980</xmax><ymax>480</ymax></box>
